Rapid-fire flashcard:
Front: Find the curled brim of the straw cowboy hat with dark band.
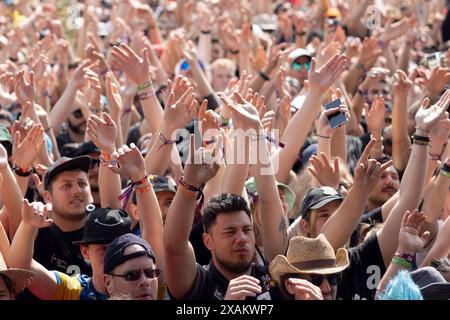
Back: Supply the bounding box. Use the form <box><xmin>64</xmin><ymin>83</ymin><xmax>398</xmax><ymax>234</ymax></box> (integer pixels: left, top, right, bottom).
<box><xmin>269</xmin><ymin>248</ymin><xmax>350</xmax><ymax>284</ymax></box>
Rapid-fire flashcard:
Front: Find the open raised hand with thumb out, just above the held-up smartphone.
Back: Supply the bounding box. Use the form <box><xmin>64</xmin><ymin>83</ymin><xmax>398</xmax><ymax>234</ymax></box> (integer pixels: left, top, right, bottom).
<box><xmin>308</xmin><ymin>55</ymin><xmax>348</xmax><ymax>94</ymax></box>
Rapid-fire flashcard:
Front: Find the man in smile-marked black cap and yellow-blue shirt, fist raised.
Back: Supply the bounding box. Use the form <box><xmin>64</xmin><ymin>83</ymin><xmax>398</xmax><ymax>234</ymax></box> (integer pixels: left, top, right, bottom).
<box><xmin>9</xmin><ymin>200</ymin><xmax>131</xmax><ymax>300</ymax></box>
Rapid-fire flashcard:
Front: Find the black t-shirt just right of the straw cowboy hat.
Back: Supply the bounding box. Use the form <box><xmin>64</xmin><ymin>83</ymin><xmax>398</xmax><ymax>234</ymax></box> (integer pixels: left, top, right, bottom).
<box><xmin>337</xmin><ymin>235</ymin><xmax>386</xmax><ymax>300</ymax></box>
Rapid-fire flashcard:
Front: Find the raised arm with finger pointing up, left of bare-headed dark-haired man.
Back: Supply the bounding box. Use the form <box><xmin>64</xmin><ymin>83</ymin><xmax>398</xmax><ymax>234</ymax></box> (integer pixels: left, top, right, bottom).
<box><xmin>164</xmin><ymin>135</ymin><xmax>219</xmax><ymax>299</ymax></box>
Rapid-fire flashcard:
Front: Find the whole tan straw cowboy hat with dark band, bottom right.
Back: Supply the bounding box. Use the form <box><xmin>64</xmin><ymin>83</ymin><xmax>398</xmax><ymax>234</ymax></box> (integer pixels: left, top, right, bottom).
<box><xmin>269</xmin><ymin>234</ymin><xmax>350</xmax><ymax>283</ymax></box>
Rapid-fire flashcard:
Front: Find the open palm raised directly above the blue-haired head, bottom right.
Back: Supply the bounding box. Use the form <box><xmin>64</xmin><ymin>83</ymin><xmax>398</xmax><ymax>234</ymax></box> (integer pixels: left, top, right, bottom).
<box><xmin>398</xmin><ymin>209</ymin><xmax>430</xmax><ymax>255</ymax></box>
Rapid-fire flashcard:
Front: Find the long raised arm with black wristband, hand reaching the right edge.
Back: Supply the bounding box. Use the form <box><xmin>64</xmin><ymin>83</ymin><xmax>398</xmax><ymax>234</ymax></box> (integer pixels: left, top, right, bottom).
<box><xmin>378</xmin><ymin>90</ymin><xmax>450</xmax><ymax>266</ymax></box>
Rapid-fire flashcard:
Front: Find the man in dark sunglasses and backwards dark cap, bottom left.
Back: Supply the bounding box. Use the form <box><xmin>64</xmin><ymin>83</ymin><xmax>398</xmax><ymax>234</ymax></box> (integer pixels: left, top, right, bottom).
<box><xmin>103</xmin><ymin>233</ymin><xmax>161</xmax><ymax>300</ymax></box>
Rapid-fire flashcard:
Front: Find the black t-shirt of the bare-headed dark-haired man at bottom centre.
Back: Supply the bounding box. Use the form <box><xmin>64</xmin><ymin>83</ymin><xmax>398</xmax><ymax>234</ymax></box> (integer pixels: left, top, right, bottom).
<box><xmin>178</xmin><ymin>262</ymin><xmax>270</xmax><ymax>300</ymax></box>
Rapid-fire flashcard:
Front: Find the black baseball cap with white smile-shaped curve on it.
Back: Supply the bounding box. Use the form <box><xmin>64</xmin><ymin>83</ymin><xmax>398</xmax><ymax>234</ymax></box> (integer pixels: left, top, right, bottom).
<box><xmin>73</xmin><ymin>208</ymin><xmax>131</xmax><ymax>245</ymax></box>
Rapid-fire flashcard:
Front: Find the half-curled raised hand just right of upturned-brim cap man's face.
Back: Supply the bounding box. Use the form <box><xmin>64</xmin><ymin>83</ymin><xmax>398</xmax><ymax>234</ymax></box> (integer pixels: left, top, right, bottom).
<box><xmin>108</xmin><ymin>143</ymin><xmax>147</xmax><ymax>181</ymax></box>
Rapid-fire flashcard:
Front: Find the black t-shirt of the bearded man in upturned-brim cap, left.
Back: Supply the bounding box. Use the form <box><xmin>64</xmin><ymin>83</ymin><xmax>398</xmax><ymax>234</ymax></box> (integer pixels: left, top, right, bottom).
<box><xmin>34</xmin><ymin>224</ymin><xmax>92</xmax><ymax>276</ymax></box>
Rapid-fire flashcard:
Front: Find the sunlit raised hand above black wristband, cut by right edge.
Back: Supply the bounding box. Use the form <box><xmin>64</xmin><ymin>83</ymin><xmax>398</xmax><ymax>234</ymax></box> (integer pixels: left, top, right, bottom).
<box><xmin>415</xmin><ymin>90</ymin><xmax>450</xmax><ymax>133</ymax></box>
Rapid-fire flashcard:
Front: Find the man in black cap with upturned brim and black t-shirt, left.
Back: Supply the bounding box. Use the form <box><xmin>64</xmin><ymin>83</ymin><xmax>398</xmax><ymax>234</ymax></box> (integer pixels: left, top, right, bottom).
<box><xmin>34</xmin><ymin>156</ymin><xmax>93</xmax><ymax>275</ymax></box>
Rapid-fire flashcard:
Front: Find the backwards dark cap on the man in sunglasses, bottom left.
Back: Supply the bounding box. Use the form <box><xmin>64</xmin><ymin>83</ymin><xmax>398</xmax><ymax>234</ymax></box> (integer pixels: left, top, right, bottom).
<box><xmin>103</xmin><ymin>233</ymin><xmax>156</xmax><ymax>274</ymax></box>
